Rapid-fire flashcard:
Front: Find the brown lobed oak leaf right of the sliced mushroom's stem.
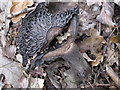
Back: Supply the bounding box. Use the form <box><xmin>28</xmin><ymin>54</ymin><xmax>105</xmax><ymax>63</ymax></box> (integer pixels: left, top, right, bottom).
<box><xmin>82</xmin><ymin>29</ymin><xmax>106</xmax><ymax>66</ymax></box>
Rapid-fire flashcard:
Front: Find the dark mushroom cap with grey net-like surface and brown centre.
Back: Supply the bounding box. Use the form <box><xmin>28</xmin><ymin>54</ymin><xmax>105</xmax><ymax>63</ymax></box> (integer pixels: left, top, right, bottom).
<box><xmin>18</xmin><ymin>2</ymin><xmax>79</xmax><ymax>66</ymax></box>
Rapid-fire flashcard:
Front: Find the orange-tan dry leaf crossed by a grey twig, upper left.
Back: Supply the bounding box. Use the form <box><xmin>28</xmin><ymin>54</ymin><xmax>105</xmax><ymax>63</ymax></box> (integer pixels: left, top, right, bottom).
<box><xmin>10</xmin><ymin>0</ymin><xmax>33</xmax><ymax>23</ymax></box>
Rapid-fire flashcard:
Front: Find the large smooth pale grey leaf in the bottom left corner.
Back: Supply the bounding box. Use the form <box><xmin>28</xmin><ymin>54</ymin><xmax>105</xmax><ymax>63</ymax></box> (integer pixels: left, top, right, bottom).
<box><xmin>0</xmin><ymin>56</ymin><xmax>23</xmax><ymax>88</ymax></box>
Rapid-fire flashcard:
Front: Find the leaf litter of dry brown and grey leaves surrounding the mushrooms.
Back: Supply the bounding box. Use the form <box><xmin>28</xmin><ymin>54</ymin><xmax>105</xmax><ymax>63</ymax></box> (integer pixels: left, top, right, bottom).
<box><xmin>0</xmin><ymin>0</ymin><xmax>120</xmax><ymax>89</ymax></box>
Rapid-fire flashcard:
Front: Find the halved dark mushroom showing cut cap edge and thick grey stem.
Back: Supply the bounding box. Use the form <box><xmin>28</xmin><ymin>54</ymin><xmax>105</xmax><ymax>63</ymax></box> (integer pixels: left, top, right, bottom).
<box><xmin>31</xmin><ymin>16</ymin><xmax>91</xmax><ymax>78</ymax></box>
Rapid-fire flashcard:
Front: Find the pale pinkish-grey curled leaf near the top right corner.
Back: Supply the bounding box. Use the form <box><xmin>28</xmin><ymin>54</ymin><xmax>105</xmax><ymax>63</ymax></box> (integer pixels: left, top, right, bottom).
<box><xmin>96</xmin><ymin>2</ymin><xmax>115</xmax><ymax>27</ymax></box>
